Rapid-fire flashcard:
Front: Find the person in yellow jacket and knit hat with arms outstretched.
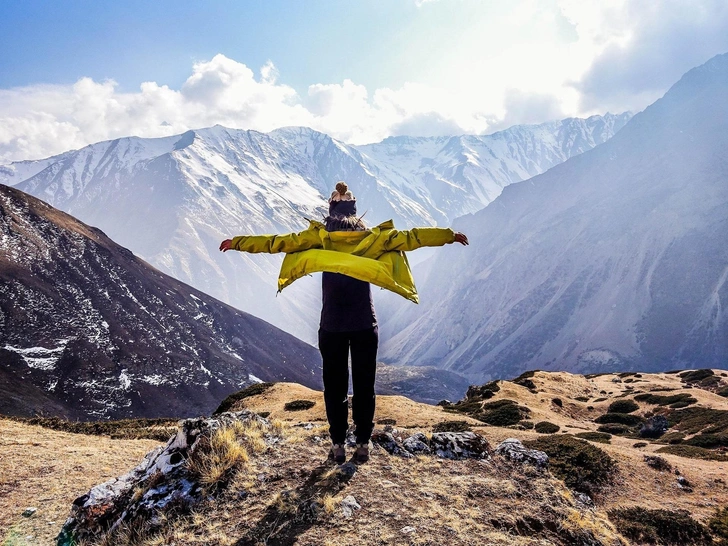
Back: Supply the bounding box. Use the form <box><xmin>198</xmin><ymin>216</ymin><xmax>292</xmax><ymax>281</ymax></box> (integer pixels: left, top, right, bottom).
<box><xmin>220</xmin><ymin>182</ymin><xmax>468</xmax><ymax>463</ymax></box>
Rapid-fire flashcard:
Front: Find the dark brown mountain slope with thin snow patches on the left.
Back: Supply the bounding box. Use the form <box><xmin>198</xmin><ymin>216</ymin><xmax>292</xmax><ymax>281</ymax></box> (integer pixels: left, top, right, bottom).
<box><xmin>0</xmin><ymin>185</ymin><xmax>321</xmax><ymax>419</ymax></box>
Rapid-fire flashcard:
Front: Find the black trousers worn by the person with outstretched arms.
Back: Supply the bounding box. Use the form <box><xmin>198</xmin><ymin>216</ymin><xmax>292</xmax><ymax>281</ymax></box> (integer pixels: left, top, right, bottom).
<box><xmin>319</xmin><ymin>326</ymin><xmax>379</xmax><ymax>444</ymax></box>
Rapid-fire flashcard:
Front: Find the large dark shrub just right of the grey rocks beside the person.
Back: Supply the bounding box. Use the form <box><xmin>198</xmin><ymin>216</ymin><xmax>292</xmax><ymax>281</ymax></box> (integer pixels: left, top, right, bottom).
<box><xmin>524</xmin><ymin>435</ymin><xmax>617</xmax><ymax>496</ymax></box>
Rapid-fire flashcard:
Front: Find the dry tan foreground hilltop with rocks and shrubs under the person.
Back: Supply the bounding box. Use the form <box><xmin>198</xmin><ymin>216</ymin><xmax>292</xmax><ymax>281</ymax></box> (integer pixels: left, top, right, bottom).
<box><xmin>0</xmin><ymin>369</ymin><xmax>728</xmax><ymax>546</ymax></box>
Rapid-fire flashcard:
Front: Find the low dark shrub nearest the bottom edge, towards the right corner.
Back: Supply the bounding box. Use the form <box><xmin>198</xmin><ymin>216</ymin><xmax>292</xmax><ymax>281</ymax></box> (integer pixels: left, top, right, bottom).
<box><xmin>607</xmin><ymin>506</ymin><xmax>712</xmax><ymax>546</ymax></box>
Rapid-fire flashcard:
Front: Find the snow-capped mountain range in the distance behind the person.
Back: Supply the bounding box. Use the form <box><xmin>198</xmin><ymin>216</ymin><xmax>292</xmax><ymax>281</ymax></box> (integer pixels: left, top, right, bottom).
<box><xmin>0</xmin><ymin>114</ymin><xmax>630</xmax><ymax>341</ymax></box>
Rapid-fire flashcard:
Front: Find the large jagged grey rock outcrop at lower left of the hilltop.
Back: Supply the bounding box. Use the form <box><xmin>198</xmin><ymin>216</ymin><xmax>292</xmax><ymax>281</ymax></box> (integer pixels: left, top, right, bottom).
<box><xmin>57</xmin><ymin>410</ymin><xmax>269</xmax><ymax>546</ymax></box>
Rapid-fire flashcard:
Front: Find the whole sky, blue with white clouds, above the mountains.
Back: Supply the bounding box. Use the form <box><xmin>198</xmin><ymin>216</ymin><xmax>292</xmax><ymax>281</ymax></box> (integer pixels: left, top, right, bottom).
<box><xmin>0</xmin><ymin>0</ymin><xmax>728</xmax><ymax>164</ymax></box>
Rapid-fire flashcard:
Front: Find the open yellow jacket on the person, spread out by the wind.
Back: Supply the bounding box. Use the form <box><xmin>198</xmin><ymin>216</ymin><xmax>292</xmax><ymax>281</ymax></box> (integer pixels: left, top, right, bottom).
<box><xmin>231</xmin><ymin>220</ymin><xmax>455</xmax><ymax>303</ymax></box>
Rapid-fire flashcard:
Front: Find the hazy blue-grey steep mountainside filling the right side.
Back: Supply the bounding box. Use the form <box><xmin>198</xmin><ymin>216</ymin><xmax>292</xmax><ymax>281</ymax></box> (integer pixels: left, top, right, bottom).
<box><xmin>382</xmin><ymin>54</ymin><xmax>728</xmax><ymax>380</ymax></box>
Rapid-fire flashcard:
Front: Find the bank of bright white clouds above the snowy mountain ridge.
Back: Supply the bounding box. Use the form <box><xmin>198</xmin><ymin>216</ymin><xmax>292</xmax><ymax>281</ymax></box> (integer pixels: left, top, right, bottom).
<box><xmin>0</xmin><ymin>0</ymin><xmax>728</xmax><ymax>163</ymax></box>
